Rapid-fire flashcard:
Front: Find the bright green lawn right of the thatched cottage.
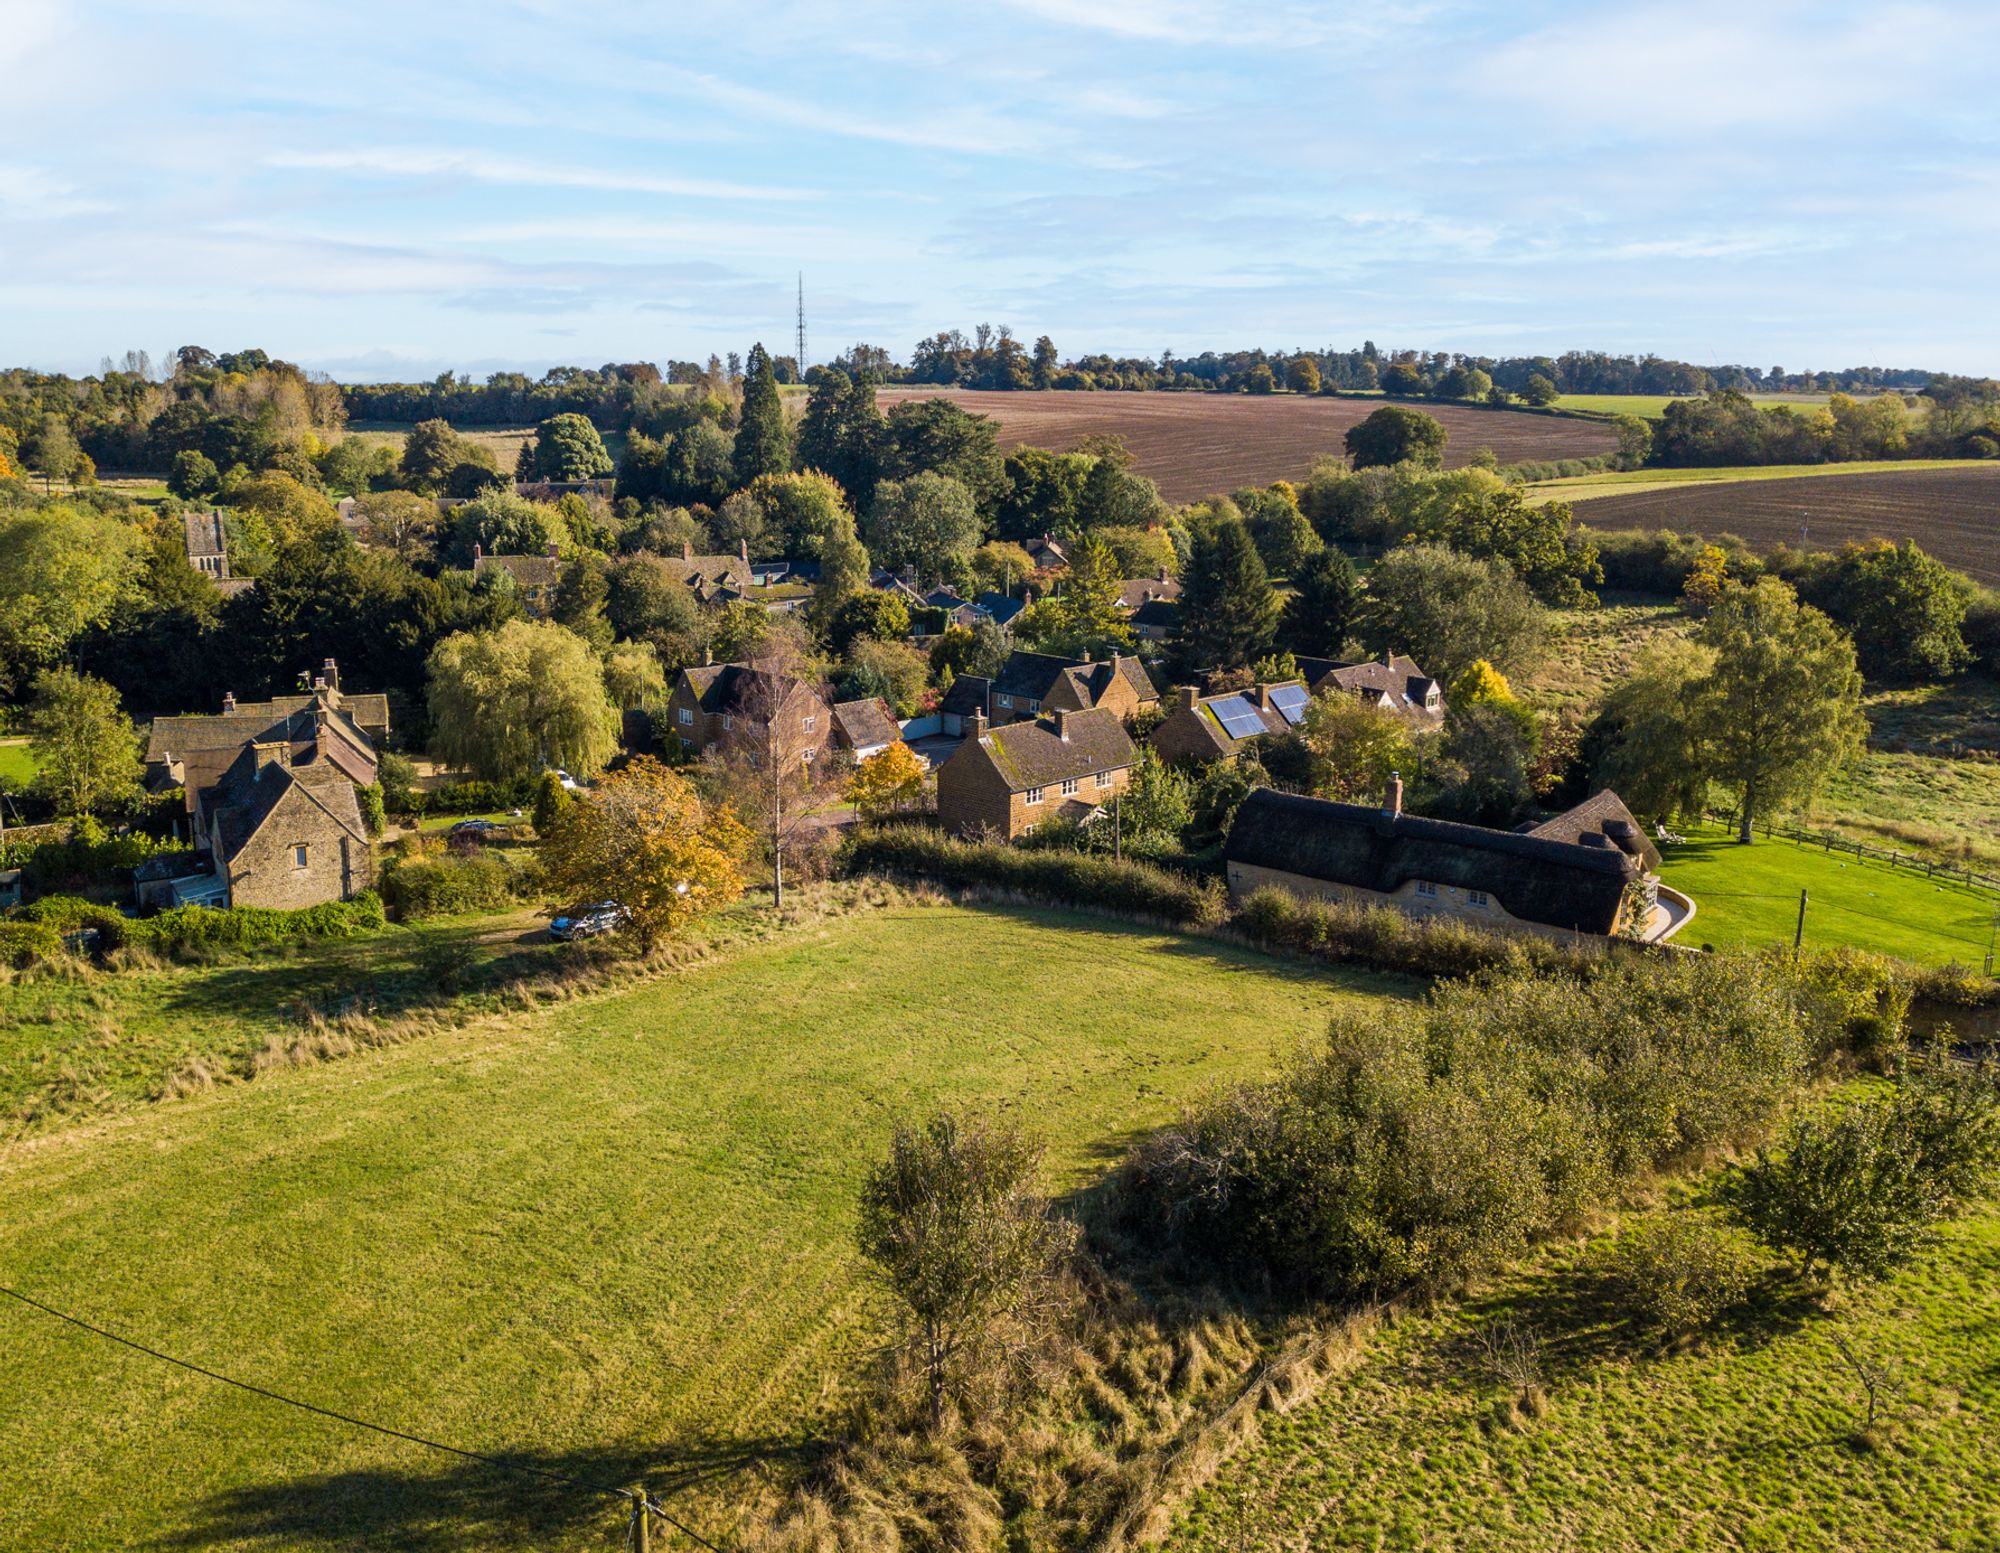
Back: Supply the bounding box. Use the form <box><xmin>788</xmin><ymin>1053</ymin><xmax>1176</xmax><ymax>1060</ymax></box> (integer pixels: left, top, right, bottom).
<box><xmin>1660</xmin><ymin>827</ymin><xmax>2000</xmax><ymax>967</ymax></box>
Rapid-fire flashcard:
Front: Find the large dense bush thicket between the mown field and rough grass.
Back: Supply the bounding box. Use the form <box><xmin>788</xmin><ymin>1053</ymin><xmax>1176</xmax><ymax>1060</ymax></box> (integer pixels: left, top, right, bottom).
<box><xmin>1118</xmin><ymin>955</ymin><xmax>1822</xmax><ymax>1299</ymax></box>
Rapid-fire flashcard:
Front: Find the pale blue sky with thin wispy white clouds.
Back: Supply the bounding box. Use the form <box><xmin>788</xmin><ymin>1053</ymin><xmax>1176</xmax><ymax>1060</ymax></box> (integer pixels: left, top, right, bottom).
<box><xmin>0</xmin><ymin>0</ymin><xmax>2000</xmax><ymax>378</ymax></box>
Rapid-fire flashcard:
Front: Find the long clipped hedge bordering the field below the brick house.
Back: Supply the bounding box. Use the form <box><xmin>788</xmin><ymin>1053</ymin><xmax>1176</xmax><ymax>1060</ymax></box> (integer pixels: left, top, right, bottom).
<box><xmin>844</xmin><ymin>825</ymin><xmax>1224</xmax><ymax>927</ymax></box>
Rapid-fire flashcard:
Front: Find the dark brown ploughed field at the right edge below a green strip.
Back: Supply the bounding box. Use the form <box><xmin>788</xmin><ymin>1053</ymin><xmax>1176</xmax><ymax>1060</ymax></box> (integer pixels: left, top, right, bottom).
<box><xmin>1576</xmin><ymin>464</ymin><xmax>2000</xmax><ymax>586</ymax></box>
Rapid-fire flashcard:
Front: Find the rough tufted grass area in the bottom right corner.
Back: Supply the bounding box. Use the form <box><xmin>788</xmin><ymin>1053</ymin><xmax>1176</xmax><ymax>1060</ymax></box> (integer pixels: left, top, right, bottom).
<box><xmin>1166</xmin><ymin>1211</ymin><xmax>2000</xmax><ymax>1553</ymax></box>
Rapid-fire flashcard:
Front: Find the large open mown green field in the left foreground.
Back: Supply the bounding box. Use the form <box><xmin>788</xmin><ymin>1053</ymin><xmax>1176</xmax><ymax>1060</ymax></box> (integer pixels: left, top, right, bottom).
<box><xmin>0</xmin><ymin>907</ymin><xmax>1396</xmax><ymax>1551</ymax></box>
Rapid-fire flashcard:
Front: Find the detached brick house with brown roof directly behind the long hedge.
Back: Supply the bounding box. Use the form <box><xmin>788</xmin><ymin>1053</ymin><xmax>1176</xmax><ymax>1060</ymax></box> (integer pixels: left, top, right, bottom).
<box><xmin>938</xmin><ymin>706</ymin><xmax>1138</xmax><ymax>841</ymax></box>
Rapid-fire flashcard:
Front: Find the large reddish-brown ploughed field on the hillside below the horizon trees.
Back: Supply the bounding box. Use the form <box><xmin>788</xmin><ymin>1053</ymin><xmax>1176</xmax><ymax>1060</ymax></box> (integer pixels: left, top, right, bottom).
<box><xmin>878</xmin><ymin>386</ymin><xmax>1618</xmax><ymax>502</ymax></box>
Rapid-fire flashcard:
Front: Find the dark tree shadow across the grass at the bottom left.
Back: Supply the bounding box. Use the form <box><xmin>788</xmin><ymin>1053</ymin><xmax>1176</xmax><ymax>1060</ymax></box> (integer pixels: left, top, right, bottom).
<box><xmin>150</xmin><ymin>1437</ymin><xmax>806</xmax><ymax>1553</ymax></box>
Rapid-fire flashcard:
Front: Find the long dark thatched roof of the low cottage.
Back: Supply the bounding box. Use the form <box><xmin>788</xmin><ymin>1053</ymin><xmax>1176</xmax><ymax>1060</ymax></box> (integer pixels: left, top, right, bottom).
<box><xmin>1222</xmin><ymin>787</ymin><xmax>1640</xmax><ymax>933</ymax></box>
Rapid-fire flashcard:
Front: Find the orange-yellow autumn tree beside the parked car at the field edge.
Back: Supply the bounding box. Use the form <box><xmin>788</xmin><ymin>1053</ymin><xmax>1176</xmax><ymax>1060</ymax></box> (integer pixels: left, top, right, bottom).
<box><xmin>538</xmin><ymin>756</ymin><xmax>750</xmax><ymax>953</ymax></box>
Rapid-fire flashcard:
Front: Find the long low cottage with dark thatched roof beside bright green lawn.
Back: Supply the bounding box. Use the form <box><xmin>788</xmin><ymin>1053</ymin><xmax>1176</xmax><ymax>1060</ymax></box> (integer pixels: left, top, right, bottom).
<box><xmin>1222</xmin><ymin>779</ymin><xmax>1694</xmax><ymax>943</ymax></box>
